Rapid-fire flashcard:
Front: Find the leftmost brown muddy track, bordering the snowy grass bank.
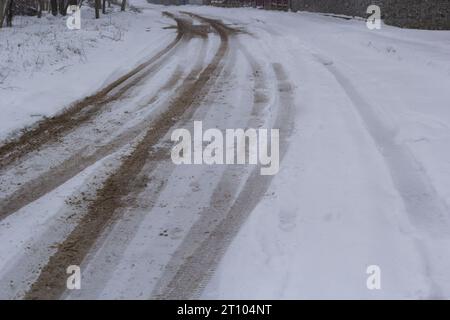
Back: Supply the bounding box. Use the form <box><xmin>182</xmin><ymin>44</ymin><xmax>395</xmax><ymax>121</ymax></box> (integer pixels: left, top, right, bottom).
<box><xmin>0</xmin><ymin>15</ymin><xmax>188</xmax><ymax>168</ymax></box>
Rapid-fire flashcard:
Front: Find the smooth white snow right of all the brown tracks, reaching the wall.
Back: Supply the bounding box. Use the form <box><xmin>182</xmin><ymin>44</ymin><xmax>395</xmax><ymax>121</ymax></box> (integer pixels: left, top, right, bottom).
<box><xmin>175</xmin><ymin>7</ymin><xmax>450</xmax><ymax>299</ymax></box>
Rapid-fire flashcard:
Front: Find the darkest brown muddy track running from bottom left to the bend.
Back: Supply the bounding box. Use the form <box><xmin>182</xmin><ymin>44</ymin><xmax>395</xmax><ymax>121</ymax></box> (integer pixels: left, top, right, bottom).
<box><xmin>25</xmin><ymin>13</ymin><xmax>236</xmax><ymax>299</ymax></box>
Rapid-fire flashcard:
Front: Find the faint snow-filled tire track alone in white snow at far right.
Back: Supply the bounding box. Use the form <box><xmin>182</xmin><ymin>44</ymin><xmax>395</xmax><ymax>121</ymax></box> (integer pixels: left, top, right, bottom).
<box><xmin>314</xmin><ymin>54</ymin><xmax>450</xmax><ymax>299</ymax></box>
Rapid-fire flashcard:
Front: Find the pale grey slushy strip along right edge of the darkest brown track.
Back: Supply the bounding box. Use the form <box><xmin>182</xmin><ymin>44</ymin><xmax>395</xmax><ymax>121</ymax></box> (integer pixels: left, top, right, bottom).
<box><xmin>62</xmin><ymin>25</ymin><xmax>235</xmax><ymax>299</ymax></box>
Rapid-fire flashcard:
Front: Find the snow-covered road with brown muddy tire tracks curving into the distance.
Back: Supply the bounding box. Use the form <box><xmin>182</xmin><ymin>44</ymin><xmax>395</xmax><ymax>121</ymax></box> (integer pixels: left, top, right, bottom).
<box><xmin>0</xmin><ymin>0</ymin><xmax>450</xmax><ymax>299</ymax></box>
